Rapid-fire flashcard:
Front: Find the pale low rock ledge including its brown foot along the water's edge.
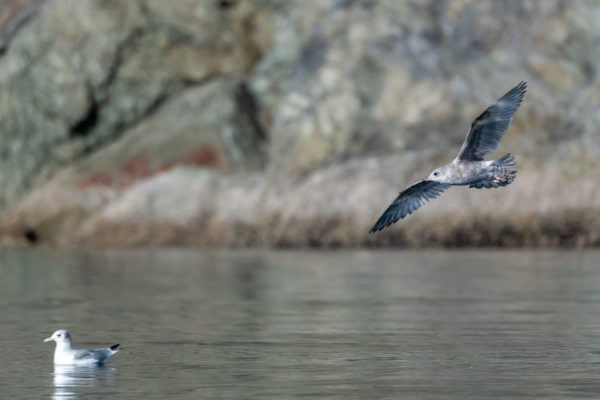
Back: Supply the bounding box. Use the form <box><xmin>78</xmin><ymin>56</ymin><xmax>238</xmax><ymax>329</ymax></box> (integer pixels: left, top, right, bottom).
<box><xmin>0</xmin><ymin>155</ymin><xmax>600</xmax><ymax>248</ymax></box>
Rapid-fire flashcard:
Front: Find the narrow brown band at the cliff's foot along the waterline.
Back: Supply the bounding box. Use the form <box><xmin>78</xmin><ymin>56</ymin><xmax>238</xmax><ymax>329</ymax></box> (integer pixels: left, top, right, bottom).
<box><xmin>0</xmin><ymin>209</ymin><xmax>600</xmax><ymax>248</ymax></box>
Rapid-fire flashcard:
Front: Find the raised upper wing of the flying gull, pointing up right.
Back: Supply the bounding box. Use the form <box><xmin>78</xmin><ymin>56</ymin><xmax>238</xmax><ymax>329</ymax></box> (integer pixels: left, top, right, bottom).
<box><xmin>456</xmin><ymin>82</ymin><xmax>527</xmax><ymax>161</ymax></box>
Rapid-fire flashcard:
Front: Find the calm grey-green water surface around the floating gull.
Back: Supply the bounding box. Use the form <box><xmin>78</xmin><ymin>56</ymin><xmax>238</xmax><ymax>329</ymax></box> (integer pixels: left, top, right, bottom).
<box><xmin>0</xmin><ymin>249</ymin><xmax>600</xmax><ymax>399</ymax></box>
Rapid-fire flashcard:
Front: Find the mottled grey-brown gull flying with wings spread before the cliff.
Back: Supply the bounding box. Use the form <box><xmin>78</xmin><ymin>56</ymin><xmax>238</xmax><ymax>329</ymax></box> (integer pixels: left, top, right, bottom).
<box><xmin>369</xmin><ymin>82</ymin><xmax>527</xmax><ymax>233</ymax></box>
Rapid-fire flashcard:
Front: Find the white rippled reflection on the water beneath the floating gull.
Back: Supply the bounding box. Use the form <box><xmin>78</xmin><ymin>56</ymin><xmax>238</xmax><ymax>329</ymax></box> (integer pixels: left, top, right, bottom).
<box><xmin>52</xmin><ymin>365</ymin><xmax>117</xmax><ymax>399</ymax></box>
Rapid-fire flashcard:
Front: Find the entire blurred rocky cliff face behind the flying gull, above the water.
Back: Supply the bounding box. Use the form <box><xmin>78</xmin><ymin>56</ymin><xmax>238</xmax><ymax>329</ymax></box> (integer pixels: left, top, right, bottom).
<box><xmin>0</xmin><ymin>0</ymin><xmax>600</xmax><ymax>246</ymax></box>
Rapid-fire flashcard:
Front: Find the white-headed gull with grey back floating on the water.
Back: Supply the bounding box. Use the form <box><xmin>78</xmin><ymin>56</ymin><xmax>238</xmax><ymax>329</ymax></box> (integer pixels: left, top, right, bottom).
<box><xmin>44</xmin><ymin>329</ymin><xmax>119</xmax><ymax>365</ymax></box>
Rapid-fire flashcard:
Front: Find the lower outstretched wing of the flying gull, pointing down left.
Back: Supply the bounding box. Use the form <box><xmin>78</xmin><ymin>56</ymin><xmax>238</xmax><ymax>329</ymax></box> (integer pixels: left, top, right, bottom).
<box><xmin>369</xmin><ymin>180</ymin><xmax>450</xmax><ymax>233</ymax></box>
